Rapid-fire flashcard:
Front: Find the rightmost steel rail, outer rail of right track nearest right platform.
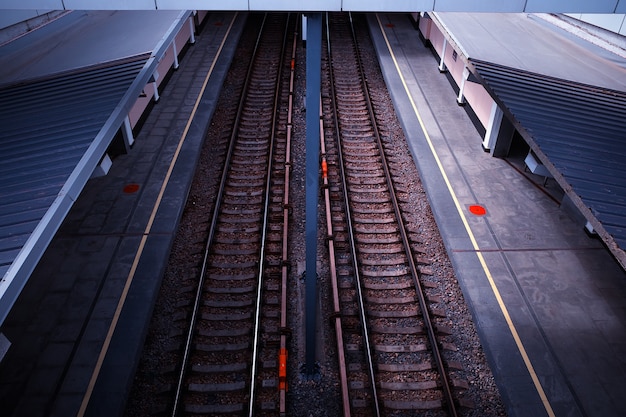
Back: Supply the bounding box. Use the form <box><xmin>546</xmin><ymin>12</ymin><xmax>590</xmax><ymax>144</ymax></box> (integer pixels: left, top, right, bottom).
<box><xmin>350</xmin><ymin>13</ymin><xmax>458</xmax><ymax>417</ymax></box>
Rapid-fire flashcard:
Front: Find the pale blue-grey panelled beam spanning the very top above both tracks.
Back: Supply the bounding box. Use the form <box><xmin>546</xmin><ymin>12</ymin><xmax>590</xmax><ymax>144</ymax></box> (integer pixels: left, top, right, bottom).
<box><xmin>0</xmin><ymin>0</ymin><xmax>626</xmax><ymax>14</ymax></box>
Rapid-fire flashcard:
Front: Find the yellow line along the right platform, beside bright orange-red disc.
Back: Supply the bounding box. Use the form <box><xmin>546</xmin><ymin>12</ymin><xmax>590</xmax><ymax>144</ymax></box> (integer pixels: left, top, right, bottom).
<box><xmin>376</xmin><ymin>14</ymin><xmax>555</xmax><ymax>417</ymax></box>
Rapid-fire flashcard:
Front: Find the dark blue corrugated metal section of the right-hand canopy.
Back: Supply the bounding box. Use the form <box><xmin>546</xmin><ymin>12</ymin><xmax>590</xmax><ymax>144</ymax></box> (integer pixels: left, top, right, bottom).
<box><xmin>470</xmin><ymin>60</ymin><xmax>626</xmax><ymax>250</ymax></box>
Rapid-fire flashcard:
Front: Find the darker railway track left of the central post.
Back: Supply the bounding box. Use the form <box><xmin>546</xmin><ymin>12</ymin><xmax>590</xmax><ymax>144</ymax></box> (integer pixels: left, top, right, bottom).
<box><xmin>156</xmin><ymin>14</ymin><xmax>296</xmax><ymax>416</ymax></box>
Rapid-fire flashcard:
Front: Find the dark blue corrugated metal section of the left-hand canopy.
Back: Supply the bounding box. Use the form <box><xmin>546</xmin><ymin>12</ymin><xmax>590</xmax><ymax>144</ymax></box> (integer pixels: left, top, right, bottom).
<box><xmin>0</xmin><ymin>54</ymin><xmax>149</xmax><ymax>277</ymax></box>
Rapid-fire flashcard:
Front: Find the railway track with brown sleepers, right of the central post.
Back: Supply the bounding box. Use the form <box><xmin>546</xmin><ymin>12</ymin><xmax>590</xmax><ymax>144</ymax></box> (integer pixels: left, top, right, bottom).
<box><xmin>322</xmin><ymin>14</ymin><xmax>466</xmax><ymax>416</ymax></box>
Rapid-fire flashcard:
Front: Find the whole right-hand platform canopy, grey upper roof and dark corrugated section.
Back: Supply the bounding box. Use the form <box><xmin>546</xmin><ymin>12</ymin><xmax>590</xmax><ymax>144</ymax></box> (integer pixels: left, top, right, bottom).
<box><xmin>432</xmin><ymin>13</ymin><xmax>626</xmax><ymax>268</ymax></box>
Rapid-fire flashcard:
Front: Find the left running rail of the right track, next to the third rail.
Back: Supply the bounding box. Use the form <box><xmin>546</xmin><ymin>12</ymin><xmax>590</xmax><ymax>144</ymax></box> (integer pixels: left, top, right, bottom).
<box><xmin>326</xmin><ymin>13</ymin><xmax>381</xmax><ymax>417</ymax></box>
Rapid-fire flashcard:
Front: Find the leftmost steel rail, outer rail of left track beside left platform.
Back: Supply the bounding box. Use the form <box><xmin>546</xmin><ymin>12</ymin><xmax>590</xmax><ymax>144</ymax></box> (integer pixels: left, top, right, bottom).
<box><xmin>171</xmin><ymin>13</ymin><xmax>267</xmax><ymax>417</ymax></box>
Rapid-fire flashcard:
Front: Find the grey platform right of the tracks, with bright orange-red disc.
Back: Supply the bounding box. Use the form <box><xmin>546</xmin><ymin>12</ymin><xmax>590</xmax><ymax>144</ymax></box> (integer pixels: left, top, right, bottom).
<box><xmin>369</xmin><ymin>14</ymin><xmax>626</xmax><ymax>417</ymax></box>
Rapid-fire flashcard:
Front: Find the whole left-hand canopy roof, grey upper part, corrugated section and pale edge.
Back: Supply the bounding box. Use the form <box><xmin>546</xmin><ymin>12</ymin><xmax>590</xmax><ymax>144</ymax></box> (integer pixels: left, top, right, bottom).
<box><xmin>0</xmin><ymin>11</ymin><xmax>191</xmax><ymax>323</ymax></box>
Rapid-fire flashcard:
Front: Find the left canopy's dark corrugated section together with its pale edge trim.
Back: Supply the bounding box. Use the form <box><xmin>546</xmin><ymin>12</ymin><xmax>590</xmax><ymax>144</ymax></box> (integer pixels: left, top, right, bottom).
<box><xmin>0</xmin><ymin>8</ymin><xmax>190</xmax><ymax>323</ymax></box>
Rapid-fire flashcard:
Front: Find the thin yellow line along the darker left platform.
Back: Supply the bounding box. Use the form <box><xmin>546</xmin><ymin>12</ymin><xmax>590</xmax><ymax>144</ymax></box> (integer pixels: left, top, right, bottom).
<box><xmin>78</xmin><ymin>13</ymin><xmax>238</xmax><ymax>417</ymax></box>
